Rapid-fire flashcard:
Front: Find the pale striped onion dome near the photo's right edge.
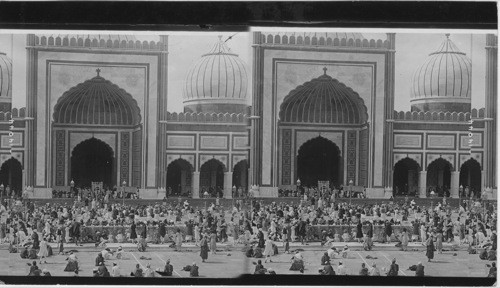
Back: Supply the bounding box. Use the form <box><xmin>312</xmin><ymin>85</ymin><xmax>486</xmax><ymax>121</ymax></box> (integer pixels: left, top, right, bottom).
<box><xmin>410</xmin><ymin>34</ymin><xmax>472</xmax><ymax>112</ymax></box>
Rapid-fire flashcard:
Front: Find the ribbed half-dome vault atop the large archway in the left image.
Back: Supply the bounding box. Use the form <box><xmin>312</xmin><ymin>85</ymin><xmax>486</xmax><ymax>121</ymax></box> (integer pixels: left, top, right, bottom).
<box><xmin>54</xmin><ymin>69</ymin><xmax>141</xmax><ymax>126</ymax></box>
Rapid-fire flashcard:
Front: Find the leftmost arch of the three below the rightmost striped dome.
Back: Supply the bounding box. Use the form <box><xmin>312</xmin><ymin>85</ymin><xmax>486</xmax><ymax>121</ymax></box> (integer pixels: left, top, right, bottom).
<box><xmin>392</xmin><ymin>157</ymin><xmax>420</xmax><ymax>195</ymax></box>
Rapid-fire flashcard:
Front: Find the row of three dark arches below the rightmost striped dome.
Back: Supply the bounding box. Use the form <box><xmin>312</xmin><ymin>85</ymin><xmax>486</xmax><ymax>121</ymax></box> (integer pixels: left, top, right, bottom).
<box><xmin>393</xmin><ymin>157</ymin><xmax>482</xmax><ymax>197</ymax></box>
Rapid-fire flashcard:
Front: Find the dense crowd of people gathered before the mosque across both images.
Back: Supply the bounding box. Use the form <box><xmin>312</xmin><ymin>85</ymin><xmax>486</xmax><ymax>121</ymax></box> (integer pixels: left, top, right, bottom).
<box><xmin>0</xmin><ymin>186</ymin><xmax>497</xmax><ymax>275</ymax></box>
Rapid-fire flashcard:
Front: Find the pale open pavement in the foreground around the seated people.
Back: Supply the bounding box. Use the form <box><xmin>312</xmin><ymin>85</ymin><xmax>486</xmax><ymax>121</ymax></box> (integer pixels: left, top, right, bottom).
<box><xmin>0</xmin><ymin>242</ymin><xmax>491</xmax><ymax>278</ymax></box>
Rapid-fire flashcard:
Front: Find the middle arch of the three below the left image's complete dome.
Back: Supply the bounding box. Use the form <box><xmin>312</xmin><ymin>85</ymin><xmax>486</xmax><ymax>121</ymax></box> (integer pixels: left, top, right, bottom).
<box><xmin>200</xmin><ymin>159</ymin><xmax>224</xmax><ymax>197</ymax></box>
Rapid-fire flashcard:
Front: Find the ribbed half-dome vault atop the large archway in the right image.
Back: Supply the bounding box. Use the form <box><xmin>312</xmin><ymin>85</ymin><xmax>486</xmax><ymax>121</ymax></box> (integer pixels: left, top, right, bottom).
<box><xmin>280</xmin><ymin>68</ymin><xmax>368</xmax><ymax>124</ymax></box>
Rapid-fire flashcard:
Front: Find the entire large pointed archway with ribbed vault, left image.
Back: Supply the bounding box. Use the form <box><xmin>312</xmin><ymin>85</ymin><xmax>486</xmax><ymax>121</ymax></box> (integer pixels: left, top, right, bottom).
<box><xmin>51</xmin><ymin>69</ymin><xmax>145</xmax><ymax>189</ymax></box>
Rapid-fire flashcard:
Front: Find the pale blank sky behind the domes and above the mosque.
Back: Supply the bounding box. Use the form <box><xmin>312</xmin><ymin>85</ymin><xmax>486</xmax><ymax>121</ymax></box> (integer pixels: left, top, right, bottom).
<box><xmin>0</xmin><ymin>30</ymin><xmax>492</xmax><ymax>112</ymax></box>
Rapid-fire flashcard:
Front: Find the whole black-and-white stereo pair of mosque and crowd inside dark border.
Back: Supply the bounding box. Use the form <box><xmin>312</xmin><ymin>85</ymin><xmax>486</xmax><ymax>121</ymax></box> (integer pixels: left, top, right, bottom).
<box><xmin>0</xmin><ymin>28</ymin><xmax>498</xmax><ymax>285</ymax></box>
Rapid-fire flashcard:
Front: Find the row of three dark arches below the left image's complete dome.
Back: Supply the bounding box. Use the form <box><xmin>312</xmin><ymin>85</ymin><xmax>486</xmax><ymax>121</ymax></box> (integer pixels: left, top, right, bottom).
<box><xmin>166</xmin><ymin>158</ymin><xmax>248</xmax><ymax>198</ymax></box>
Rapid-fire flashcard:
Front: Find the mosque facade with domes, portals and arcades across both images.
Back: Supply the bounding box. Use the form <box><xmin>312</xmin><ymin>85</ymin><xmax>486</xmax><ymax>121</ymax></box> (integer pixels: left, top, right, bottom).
<box><xmin>0</xmin><ymin>32</ymin><xmax>497</xmax><ymax>199</ymax></box>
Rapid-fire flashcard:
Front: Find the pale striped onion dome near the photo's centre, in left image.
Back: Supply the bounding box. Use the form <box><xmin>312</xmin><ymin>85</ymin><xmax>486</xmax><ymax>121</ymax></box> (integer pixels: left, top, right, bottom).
<box><xmin>184</xmin><ymin>36</ymin><xmax>248</xmax><ymax>113</ymax></box>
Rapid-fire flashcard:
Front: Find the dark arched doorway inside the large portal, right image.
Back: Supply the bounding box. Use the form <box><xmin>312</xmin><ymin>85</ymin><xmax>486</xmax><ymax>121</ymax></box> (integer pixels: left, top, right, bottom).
<box><xmin>297</xmin><ymin>136</ymin><xmax>343</xmax><ymax>187</ymax></box>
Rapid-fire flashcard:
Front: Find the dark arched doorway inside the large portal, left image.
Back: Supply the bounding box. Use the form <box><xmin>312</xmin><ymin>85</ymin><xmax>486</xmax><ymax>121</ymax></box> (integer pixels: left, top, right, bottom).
<box><xmin>71</xmin><ymin>138</ymin><xmax>116</xmax><ymax>188</ymax></box>
